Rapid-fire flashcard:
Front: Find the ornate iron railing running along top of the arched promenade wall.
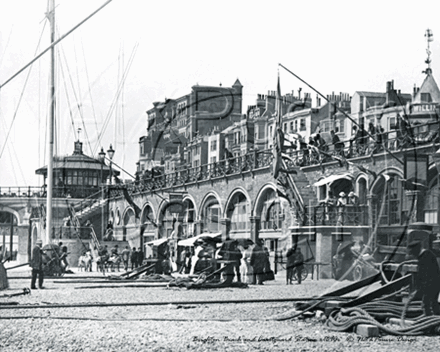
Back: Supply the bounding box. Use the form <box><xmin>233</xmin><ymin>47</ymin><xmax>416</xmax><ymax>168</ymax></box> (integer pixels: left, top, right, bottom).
<box><xmin>0</xmin><ymin>122</ymin><xmax>440</xmax><ymax>198</ymax></box>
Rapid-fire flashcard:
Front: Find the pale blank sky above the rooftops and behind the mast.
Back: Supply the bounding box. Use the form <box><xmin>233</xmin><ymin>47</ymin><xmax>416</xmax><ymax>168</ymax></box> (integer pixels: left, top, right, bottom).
<box><xmin>0</xmin><ymin>0</ymin><xmax>440</xmax><ymax>187</ymax></box>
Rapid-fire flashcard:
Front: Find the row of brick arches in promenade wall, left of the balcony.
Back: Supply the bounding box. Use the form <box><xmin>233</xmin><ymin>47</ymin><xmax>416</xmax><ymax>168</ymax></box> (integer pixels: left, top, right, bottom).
<box><xmin>111</xmin><ymin>183</ymin><xmax>292</xmax><ymax>238</ymax></box>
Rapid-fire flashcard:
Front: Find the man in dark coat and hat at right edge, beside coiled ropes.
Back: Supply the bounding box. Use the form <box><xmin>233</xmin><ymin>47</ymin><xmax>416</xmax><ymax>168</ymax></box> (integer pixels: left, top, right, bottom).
<box><xmin>407</xmin><ymin>241</ymin><xmax>440</xmax><ymax>316</ymax></box>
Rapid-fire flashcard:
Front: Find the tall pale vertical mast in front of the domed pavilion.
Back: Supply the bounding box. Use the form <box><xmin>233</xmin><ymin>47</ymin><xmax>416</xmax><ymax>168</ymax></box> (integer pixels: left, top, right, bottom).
<box><xmin>43</xmin><ymin>0</ymin><xmax>55</xmax><ymax>244</ymax></box>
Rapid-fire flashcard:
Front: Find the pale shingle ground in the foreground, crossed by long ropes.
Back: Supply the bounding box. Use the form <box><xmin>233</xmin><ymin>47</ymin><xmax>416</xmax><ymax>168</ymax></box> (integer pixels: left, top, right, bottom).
<box><xmin>0</xmin><ymin>271</ymin><xmax>440</xmax><ymax>352</ymax></box>
